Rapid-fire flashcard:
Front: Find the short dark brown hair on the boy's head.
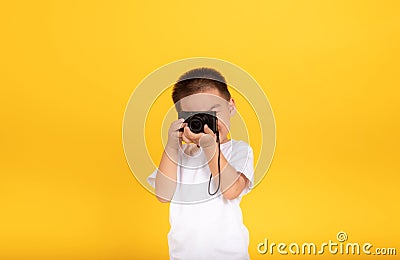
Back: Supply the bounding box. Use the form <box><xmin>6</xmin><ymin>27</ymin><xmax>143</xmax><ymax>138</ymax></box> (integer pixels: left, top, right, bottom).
<box><xmin>172</xmin><ymin>67</ymin><xmax>231</xmax><ymax>111</ymax></box>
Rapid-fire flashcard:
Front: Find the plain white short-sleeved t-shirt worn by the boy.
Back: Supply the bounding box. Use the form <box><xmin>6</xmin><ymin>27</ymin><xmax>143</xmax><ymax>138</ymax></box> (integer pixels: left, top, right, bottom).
<box><xmin>147</xmin><ymin>140</ymin><xmax>254</xmax><ymax>260</ymax></box>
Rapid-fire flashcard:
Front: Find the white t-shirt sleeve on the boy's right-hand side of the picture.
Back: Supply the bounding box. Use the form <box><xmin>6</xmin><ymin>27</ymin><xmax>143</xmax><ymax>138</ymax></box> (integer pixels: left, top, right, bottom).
<box><xmin>229</xmin><ymin>141</ymin><xmax>254</xmax><ymax>196</ymax></box>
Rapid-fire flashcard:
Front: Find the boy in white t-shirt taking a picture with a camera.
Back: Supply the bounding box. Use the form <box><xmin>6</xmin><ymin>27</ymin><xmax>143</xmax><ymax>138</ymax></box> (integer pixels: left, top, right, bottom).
<box><xmin>147</xmin><ymin>68</ymin><xmax>254</xmax><ymax>260</ymax></box>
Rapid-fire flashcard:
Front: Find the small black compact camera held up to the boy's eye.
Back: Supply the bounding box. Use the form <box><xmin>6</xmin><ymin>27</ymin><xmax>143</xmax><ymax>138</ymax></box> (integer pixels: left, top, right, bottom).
<box><xmin>178</xmin><ymin>111</ymin><xmax>218</xmax><ymax>134</ymax></box>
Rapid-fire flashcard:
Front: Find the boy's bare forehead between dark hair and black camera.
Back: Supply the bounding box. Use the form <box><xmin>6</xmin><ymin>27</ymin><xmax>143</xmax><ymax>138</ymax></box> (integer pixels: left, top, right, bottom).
<box><xmin>179</xmin><ymin>90</ymin><xmax>228</xmax><ymax>111</ymax></box>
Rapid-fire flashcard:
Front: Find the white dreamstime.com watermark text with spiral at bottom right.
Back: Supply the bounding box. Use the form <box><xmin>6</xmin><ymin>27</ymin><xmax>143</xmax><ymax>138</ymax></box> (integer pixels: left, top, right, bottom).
<box><xmin>257</xmin><ymin>231</ymin><xmax>396</xmax><ymax>255</ymax></box>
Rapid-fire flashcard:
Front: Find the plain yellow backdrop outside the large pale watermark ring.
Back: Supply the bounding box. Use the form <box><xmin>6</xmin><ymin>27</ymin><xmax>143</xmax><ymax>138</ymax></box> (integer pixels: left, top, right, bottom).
<box><xmin>0</xmin><ymin>1</ymin><xmax>400</xmax><ymax>259</ymax></box>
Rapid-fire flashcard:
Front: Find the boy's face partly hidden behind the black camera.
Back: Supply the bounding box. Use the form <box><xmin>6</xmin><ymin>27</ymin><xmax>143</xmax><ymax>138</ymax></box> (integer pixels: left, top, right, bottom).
<box><xmin>179</xmin><ymin>88</ymin><xmax>236</xmax><ymax>142</ymax></box>
